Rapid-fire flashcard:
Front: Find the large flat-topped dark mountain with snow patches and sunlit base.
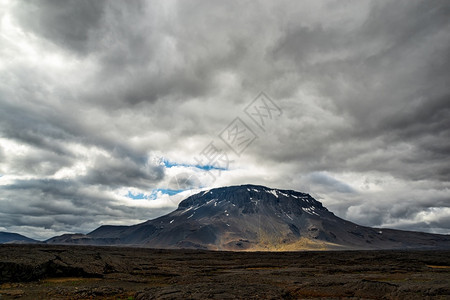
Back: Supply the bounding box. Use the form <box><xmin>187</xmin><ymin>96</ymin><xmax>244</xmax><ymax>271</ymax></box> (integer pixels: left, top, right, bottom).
<box><xmin>47</xmin><ymin>185</ymin><xmax>450</xmax><ymax>251</ymax></box>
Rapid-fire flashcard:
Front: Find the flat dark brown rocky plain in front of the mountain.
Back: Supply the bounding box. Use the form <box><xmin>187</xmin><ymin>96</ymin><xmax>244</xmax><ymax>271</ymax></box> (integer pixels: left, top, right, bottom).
<box><xmin>0</xmin><ymin>245</ymin><xmax>450</xmax><ymax>300</ymax></box>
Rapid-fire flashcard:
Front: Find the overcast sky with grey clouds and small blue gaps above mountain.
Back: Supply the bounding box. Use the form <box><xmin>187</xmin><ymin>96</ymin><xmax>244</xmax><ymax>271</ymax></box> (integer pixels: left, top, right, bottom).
<box><xmin>0</xmin><ymin>0</ymin><xmax>450</xmax><ymax>239</ymax></box>
